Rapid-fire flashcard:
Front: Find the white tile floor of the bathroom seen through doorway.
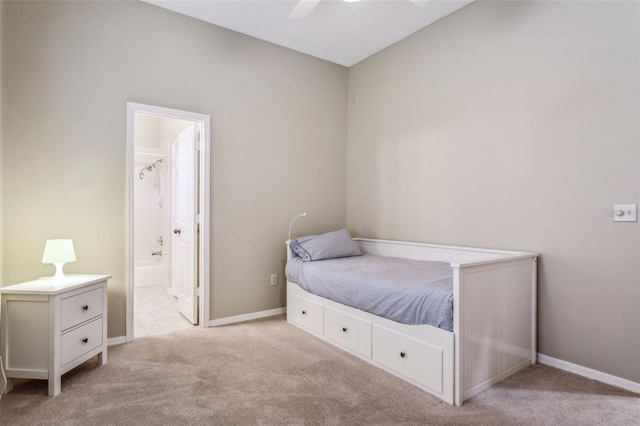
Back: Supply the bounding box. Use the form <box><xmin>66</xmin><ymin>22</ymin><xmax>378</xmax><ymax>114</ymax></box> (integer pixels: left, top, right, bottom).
<box><xmin>133</xmin><ymin>286</ymin><xmax>193</xmax><ymax>338</ymax></box>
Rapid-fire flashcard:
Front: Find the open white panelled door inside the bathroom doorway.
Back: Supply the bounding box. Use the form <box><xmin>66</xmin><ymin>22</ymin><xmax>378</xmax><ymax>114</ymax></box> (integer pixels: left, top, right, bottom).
<box><xmin>171</xmin><ymin>124</ymin><xmax>198</xmax><ymax>324</ymax></box>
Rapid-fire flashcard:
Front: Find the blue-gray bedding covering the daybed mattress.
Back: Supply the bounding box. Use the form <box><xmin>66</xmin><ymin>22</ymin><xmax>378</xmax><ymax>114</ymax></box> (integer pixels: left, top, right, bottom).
<box><xmin>285</xmin><ymin>254</ymin><xmax>453</xmax><ymax>331</ymax></box>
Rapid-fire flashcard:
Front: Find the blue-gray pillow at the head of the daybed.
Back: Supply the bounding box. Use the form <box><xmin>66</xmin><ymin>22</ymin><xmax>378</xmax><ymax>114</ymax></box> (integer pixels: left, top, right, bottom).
<box><xmin>289</xmin><ymin>228</ymin><xmax>362</xmax><ymax>262</ymax></box>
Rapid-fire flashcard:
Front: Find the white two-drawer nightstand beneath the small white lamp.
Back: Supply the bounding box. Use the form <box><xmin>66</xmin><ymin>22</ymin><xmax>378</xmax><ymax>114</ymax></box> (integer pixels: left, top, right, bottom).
<box><xmin>0</xmin><ymin>275</ymin><xmax>111</xmax><ymax>396</ymax></box>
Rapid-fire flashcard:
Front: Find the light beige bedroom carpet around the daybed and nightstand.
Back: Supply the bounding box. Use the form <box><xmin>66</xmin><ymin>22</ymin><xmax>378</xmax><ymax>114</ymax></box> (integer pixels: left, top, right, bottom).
<box><xmin>0</xmin><ymin>316</ymin><xmax>640</xmax><ymax>425</ymax></box>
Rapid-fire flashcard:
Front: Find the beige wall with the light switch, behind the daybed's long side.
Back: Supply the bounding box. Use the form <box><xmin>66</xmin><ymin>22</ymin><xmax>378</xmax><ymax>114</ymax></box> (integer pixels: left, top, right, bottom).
<box><xmin>348</xmin><ymin>2</ymin><xmax>640</xmax><ymax>382</ymax></box>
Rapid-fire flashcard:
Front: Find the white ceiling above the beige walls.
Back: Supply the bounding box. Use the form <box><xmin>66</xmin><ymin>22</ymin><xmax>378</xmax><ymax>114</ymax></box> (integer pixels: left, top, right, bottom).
<box><xmin>142</xmin><ymin>0</ymin><xmax>473</xmax><ymax>67</ymax></box>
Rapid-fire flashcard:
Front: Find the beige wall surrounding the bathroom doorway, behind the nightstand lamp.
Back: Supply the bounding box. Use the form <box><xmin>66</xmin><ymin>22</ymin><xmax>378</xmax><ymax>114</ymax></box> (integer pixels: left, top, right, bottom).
<box><xmin>2</xmin><ymin>2</ymin><xmax>347</xmax><ymax>337</ymax></box>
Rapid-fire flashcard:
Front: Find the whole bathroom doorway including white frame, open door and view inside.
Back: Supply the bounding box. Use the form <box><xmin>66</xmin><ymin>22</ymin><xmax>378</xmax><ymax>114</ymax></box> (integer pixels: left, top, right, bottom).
<box><xmin>126</xmin><ymin>103</ymin><xmax>210</xmax><ymax>341</ymax></box>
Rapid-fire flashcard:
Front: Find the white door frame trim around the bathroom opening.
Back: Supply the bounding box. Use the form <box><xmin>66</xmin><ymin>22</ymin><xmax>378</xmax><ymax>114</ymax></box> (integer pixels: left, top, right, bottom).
<box><xmin>125</xmin><ymin>102</ymin><xmax>211</xmax><ymax>342</ymax></box>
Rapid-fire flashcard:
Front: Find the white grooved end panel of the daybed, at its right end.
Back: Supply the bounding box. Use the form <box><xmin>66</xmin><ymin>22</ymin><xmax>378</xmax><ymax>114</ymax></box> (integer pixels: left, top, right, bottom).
<box><xmin>453</xmin><ymin>257</ymin><xmax>536</xmax><ymax>405</ymax></box>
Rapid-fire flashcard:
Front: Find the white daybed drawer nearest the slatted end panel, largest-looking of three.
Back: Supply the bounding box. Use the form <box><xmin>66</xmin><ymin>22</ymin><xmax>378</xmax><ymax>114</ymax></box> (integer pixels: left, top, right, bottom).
<box><xmin>372</xmin><ymin>324</ymin><xmax>443</xmax><ymax>393</ymax></box>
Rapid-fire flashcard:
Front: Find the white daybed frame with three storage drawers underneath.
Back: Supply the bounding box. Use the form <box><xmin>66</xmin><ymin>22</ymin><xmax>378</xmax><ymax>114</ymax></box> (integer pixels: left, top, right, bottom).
<box><xmin>287</xmin><ymin>238</ymin><xmax>538</xmax><ymax>405</ymax></box>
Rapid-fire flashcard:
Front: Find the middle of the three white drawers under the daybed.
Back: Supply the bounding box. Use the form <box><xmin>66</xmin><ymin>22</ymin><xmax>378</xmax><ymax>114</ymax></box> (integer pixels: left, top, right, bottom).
<box><xmin>324</xmin><ymin>306</ymin><xmax>371</xmax><ymax>358</ymax></box>
